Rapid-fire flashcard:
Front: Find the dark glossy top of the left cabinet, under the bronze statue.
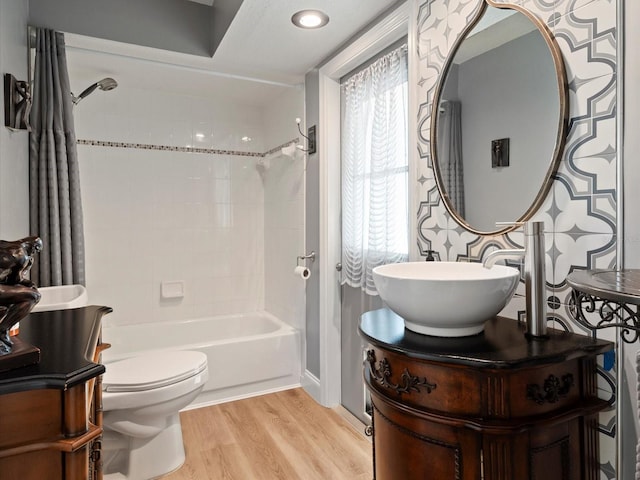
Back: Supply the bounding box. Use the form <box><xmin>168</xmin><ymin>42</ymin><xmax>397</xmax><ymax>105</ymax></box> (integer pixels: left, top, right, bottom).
<box><xmin>0</xmin><ymin>306</ymin><xmax>112</xmax><ymax>394</ymax></box>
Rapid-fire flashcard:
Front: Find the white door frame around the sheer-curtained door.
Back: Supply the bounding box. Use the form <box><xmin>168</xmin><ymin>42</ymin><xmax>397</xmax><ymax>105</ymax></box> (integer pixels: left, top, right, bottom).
<box><xmin>318</xmin><ymin>0</ymin><xmax>415</xmax><ymax>407</ymax></box>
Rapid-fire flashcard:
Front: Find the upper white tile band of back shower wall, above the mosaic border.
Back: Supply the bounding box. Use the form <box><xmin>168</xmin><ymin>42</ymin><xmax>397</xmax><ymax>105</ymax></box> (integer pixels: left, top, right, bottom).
<box><xmin>70</xmin><ymin>85</ymin><xmax>270</xmax><ymax>152</ymax></box>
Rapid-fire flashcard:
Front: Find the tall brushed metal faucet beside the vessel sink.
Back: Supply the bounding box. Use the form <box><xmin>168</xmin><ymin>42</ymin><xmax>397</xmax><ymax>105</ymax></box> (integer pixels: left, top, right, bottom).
<box><xmin>482</xmin><ymin>222</ymin><xmax>547</xmax><ymax>337</ymax></box>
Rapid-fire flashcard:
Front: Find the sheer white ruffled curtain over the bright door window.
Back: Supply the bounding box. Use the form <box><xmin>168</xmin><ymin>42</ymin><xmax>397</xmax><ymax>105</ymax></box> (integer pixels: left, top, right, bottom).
<box><xmin>341</xmin><ymin>45</ymin><xmax>409</xmax><ymax>295</ymax></box>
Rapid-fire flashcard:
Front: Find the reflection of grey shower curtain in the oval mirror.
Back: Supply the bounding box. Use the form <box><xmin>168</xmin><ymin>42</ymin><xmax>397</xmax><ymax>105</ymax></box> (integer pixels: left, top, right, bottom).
<box><xmin>438</xmin><ymin>100</ymin><xmax>464</xmax><ymax>216</ymax></box>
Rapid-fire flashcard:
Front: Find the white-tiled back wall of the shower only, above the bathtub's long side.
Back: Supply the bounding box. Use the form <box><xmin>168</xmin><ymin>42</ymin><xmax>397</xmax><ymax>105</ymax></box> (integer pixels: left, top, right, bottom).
<box><xmin>74</xmin><ymin>87</ymin><xmax>265</xmax><ymax>324</ymax></box>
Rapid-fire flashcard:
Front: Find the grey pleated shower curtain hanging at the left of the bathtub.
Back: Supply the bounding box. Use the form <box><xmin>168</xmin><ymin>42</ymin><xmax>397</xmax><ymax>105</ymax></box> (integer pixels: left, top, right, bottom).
<box><xmin>29</xmin><ymin>28</ymin><xmax>85</xmax><ymax>287</ymax></box>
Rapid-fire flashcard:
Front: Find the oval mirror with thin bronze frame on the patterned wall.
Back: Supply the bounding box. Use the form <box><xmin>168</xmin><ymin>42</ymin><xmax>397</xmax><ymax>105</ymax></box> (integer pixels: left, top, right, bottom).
<box><xmin>431</xmin><ymin>0</ymin><xmax>568</xmax><ymax>234</ymax></box>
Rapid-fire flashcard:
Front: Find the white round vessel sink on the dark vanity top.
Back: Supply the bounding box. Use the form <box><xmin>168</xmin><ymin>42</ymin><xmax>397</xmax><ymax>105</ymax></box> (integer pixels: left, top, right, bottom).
<box><xmin>373</xmin><ymin>262</ymin><xmax>520</xmax><ymax>337</ymax></box>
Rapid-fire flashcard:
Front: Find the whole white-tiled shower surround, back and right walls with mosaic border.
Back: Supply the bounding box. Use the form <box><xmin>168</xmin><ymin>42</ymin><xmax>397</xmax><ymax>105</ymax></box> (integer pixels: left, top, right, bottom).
<box><xmin>70</xmin><ymin>80</ymin><xmax>304</xmax><ymax>334</ymax></box>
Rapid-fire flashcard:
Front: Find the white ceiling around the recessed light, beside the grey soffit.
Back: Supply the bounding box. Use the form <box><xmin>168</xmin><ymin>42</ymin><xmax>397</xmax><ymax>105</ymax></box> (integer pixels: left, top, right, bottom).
<box><xmin>66</xmin><ymin>0</ymin><xmax>401</xmax><ymax>104</ymax></box>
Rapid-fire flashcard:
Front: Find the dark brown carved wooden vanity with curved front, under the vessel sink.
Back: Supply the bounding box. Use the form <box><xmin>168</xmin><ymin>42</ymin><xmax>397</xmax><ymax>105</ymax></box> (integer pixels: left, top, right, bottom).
<box><xmin>359</xmin><ymin>309</ymin><xmax>614</xmax><ymax>480</ymax></box>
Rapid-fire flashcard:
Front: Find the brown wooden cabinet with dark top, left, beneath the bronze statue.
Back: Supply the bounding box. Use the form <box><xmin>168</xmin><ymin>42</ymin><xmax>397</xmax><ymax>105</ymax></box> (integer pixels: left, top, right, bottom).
<box><xmin>0</xmin><ymin>306</ymin><xmax>111</xmax><ymax>480</ymax></box>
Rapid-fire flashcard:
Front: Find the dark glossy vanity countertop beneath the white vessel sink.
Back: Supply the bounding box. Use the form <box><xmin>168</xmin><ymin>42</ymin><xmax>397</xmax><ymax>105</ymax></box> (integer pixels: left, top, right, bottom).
<box><xmin>358</xmin><ymin>308</ymin><xmax>614</xmax><ymax>368</ymax></box>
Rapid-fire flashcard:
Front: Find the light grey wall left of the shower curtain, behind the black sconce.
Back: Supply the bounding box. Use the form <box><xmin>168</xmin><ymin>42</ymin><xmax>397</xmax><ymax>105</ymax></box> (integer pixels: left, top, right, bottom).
<box><xmin>0</xmin><ymin>0</ymin><xmax>29</xmax><ymax>240</ymax></box>
